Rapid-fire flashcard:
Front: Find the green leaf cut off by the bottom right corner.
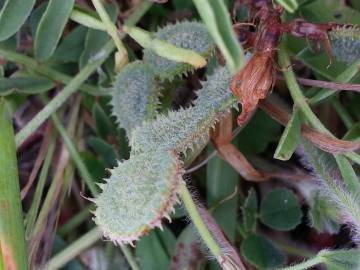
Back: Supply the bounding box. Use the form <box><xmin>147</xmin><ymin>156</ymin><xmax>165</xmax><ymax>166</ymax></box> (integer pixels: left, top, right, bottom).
<box><xmin>319</xmin><ymin>249</ymin><xmax>360</xmax><ymax>270</ymax></box>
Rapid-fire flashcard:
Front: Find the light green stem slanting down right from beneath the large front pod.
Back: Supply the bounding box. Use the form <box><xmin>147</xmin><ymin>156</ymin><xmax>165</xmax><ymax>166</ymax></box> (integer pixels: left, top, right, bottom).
<box><xmin>180</xmin><ymin>183</ymin><xmax>222</xmax><ymax>260</ymax></box>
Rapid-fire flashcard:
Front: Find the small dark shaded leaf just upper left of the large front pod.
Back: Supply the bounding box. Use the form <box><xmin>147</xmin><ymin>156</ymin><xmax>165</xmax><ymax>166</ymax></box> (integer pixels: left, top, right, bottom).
<box><xmin>87</xmin><ymin>137</ymin><xmax>117</xmax><ymax>168</ymax></box>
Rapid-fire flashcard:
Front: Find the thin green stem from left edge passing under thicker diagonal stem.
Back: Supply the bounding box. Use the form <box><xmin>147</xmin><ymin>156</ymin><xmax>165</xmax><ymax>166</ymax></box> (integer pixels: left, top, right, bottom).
<box><xmin>0</xmin><ymin>47</ymin><xmax>99</xmax><ymax>94</ymax></box>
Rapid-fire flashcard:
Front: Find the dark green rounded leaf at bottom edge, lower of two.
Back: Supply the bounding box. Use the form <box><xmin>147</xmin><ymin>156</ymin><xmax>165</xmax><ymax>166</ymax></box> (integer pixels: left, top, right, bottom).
<box><xmin>241</xmin><ymin>234</ymin><xmax>285</xmax><ymax>269</ymax></box>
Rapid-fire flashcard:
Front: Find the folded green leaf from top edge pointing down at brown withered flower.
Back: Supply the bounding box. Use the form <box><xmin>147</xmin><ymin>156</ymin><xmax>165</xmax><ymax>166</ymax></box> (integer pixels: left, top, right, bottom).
<box><xmin>194</xmin><ymin>0</ymin><xmax>244</xmax><ymax>73</ymax></box>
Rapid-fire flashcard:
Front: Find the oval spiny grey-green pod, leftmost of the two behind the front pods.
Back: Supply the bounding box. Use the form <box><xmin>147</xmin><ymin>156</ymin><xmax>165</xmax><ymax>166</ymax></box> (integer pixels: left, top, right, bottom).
<box><xmin>111</xmin><ymin>61</ymin><xmax>160</xmax><ymax>137</ymax></box>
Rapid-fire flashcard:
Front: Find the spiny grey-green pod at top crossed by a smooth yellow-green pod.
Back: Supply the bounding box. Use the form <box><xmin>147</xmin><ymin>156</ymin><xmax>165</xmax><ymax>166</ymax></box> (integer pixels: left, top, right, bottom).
<box><xmin>144</xmin><ymin>21</ymin><xmax>215</xmax><ymax>80</ymax></box>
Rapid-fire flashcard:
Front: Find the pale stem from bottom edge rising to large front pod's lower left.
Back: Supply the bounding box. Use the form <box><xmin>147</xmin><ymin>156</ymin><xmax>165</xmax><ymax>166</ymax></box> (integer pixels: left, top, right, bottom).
<box><xmin>46</xmin><ymin>227</ymin><xmax>102</xmax><ymax>270</ymax></box>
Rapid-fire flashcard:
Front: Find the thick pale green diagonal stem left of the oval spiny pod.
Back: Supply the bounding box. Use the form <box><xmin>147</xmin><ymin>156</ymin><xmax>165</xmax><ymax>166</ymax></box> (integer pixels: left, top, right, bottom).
<box><xmin>15</xmin><ymin>41</ymin><xmax>114</xmax><ymax>147</ymax></box>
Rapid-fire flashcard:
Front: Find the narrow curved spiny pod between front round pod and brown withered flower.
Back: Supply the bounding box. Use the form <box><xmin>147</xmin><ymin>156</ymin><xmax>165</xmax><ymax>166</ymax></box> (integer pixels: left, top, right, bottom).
<box><xmin>130</xmin><ymin>67</ymin><xmax>236</xmax><ymax>153</ymax></box>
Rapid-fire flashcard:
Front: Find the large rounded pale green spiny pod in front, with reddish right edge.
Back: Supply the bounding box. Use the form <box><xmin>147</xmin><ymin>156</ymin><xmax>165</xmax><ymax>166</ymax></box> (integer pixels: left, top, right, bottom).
<box><xmin>93</xmin><ymin>151</ymin><xmax>184</xmax><ymax>244</ymax></box>
